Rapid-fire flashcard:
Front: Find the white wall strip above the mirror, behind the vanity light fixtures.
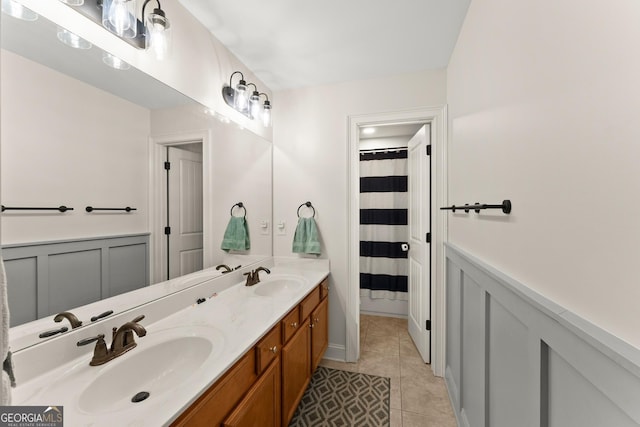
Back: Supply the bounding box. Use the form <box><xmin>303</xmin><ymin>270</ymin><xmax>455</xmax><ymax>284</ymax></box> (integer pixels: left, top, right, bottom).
<box><xmin>18</xmin><ymin>0</ymin><xmax>278</xmax><ymax>140</ymax></box>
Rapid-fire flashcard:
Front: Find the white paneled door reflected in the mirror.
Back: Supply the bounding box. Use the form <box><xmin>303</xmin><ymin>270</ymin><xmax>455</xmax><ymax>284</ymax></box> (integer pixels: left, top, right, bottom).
<box><xmin>167</xmin><ymin>146</ymin><xmax>202</xmax><ymax>279</ymax></box>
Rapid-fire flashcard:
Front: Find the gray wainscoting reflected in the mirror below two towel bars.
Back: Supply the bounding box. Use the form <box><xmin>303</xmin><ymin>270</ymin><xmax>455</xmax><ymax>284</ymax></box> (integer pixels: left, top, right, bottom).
<box><xmin>2</xmin><ymin>233</ymin><xmax>149</xmax><ymax>326</ymax></box>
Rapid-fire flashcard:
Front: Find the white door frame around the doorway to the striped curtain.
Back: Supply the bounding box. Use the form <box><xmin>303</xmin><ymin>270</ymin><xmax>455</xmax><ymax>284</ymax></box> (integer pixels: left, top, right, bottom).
<box><xmin>345</xmin><ymin>106</ymin><xmax>446</xmax><ymax>376</ymax></box>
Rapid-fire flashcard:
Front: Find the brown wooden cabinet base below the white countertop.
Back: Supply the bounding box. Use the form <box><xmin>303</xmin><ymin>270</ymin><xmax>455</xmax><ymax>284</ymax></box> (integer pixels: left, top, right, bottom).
<box><xmin>172</xmin><ymin>279</ymin><xmax>329</xmax><ymax>427</ymax></box>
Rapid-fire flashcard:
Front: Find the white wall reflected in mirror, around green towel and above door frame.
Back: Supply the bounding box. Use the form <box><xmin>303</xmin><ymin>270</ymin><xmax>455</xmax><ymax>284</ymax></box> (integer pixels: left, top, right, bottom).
<box><xmin>151</xmin><ymin>106</ymin><xmax>273</xmax><ymax>265</ymax></box>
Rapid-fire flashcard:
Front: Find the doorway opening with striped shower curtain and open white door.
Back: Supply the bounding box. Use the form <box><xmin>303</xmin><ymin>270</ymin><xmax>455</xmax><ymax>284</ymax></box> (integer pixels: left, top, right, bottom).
<box><xmin>359</xmin><ymin>123</ymin><xmax>431</xmax><ymax>363</ymax></box>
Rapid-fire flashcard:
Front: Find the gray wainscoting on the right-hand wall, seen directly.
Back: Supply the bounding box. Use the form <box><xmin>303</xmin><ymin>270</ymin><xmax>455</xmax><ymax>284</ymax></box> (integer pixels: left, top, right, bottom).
<box><xmin>445</xmin><ymin>244</ymin><xmax>640</xmax><ymax>427</ymax></box>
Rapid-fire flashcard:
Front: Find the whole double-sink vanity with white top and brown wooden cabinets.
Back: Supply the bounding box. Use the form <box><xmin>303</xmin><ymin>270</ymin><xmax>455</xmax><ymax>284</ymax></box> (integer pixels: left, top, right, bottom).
<box><xmin>12</xmin><ymin>259</ymin><xmax>329</xmax><ymax>426</ymax></box>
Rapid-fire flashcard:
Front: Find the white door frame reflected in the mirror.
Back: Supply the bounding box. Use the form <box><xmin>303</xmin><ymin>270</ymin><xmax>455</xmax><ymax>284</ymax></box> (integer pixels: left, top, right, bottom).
<box><xmin>149</xmin><ymin>130</ymin><xmax>213</xmax><ymax>283</ymax></box>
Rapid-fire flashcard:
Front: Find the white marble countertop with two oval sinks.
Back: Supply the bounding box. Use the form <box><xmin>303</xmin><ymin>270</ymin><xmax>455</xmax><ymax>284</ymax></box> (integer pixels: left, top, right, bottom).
<box><xmin>12</xmin><ymin>259</ymin><xmax>329</xmax><ymax>427</ymax></box>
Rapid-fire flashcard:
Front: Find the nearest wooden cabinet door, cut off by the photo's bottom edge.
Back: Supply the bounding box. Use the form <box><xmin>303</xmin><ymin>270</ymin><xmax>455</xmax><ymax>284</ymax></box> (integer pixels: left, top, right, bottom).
<box><xmin>222</xmin><ymin>359</ymin><xmax>281</xmax><ymax>427</ymax></box>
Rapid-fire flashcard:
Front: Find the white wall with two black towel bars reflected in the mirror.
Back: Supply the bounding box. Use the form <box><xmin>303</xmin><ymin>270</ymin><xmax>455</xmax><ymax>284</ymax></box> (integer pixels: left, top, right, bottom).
<box><xmin>0</xmin><ymin>50</ymin><xmax>150</xmax><ymax>244</ymax></box>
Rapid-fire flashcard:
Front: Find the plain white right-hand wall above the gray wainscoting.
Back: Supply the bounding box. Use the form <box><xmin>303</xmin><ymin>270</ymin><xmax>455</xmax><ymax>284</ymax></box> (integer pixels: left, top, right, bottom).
<box><xmin>447</xmin><ymin>0</ymin><xmax>640</xmax><ymax>347</ymax></box>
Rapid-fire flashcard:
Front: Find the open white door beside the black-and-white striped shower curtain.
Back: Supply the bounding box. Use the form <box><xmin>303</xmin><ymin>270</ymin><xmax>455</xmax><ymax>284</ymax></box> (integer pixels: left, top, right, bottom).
<box><xmin>408</xmin><ymin>125</ymin><xmax>431</xmax><ymax>363</ymax></box>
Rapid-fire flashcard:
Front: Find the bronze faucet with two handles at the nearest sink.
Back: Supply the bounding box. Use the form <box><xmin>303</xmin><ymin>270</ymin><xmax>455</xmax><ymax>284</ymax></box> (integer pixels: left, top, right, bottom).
<box><xmin>77</xmin><ymin>316</ymin><xmax>147</xmax><ymax>366</ymax></box>
